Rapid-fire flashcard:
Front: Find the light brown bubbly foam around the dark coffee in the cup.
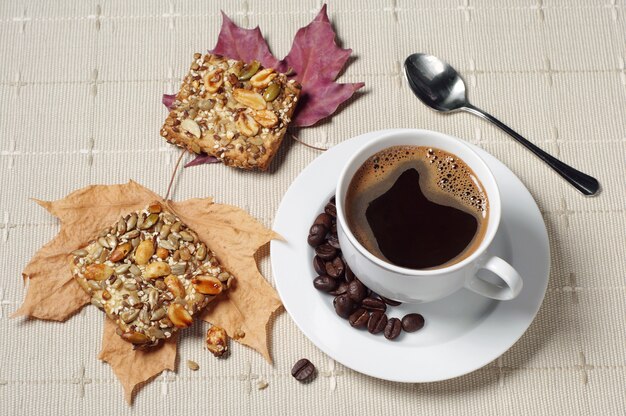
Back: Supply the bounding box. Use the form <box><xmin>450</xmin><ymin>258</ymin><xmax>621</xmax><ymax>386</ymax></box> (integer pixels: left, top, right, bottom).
<box><xmin>345</xmin><ymin>146</ymin><xmax>489</xmax><ymax>267</ymax></box>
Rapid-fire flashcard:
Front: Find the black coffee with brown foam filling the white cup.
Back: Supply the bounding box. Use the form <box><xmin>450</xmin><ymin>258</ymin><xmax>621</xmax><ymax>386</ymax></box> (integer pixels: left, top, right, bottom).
<box><xmin>345</xmin><ymin>146</ymin><xmax>489</xmax><ymax>269</ymax></box>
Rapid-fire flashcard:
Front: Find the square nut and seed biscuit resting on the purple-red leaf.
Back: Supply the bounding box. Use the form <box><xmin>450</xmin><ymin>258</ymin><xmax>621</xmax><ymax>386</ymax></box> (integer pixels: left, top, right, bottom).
<box><xmin>161</xmin><ymin>53</ymin><xmax>301</xmax><ymax>170</ymax></box>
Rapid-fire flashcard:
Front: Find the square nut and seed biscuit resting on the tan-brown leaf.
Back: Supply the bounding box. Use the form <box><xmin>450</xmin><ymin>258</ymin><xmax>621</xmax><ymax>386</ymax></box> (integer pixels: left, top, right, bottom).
<box><xmin>72</xmin><ymin>203</ymin><xmax>234</xmax><ymax>348</ymax></box>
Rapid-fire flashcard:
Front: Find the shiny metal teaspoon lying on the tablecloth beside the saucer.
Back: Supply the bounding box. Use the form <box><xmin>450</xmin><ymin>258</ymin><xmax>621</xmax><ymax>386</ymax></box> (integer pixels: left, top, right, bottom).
<box><xmin>404</xmin><ymin>53</ymin><xmax>600</xmax><ymax>195</ymax></box>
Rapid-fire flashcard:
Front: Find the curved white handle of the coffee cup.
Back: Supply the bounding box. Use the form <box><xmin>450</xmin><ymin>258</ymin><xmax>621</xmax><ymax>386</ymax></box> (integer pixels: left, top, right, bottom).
<box><xmin>465</xmin><ymin>256</ymin><xmax>523</xmax><ymax>300</ymax></box>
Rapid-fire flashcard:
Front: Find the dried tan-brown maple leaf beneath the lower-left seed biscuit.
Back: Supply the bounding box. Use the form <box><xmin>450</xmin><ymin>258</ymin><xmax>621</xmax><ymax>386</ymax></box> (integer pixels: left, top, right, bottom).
<box><xmin>13</xmin><ymin>181</ymin><xmax>280</xmax><ymax>403</ymax></box>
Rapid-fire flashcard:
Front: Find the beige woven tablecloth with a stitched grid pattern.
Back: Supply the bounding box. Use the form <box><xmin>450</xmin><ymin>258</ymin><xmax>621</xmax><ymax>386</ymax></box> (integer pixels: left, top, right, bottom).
<box><xmin>0</xmin><ymin>0</ymin><xmax>626</xmax><ymax>415</ymax></box>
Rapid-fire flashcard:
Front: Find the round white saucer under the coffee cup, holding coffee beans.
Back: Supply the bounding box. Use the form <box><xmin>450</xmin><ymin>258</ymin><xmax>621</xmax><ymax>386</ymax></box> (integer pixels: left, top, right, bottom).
<box><xmin>271</xmin><ymin>128</ymin><xmax>550</xmax><ymax>382</ymax></box>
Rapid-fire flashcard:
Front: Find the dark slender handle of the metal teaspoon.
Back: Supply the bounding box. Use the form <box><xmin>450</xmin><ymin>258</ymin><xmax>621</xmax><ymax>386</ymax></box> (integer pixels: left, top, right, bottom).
<box><xmin>461</xmin><ymin>104</ymin><xmax>600</xmax><ymax>196</ymax></box>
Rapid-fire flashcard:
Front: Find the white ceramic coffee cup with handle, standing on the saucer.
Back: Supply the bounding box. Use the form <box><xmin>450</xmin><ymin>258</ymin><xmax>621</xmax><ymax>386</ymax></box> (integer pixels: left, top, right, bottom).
<box><xmin>335</xmin><ymin>129</ymin><xmax>522</xmax><ymax>303</ymax></box>
